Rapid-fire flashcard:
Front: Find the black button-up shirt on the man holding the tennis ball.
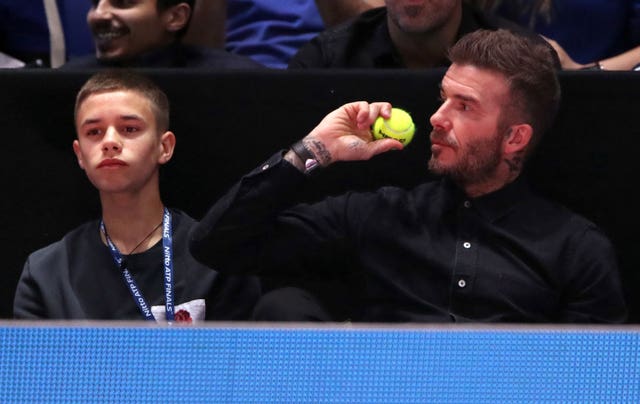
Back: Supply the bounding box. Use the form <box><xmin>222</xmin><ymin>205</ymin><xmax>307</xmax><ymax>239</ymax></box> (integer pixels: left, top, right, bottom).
<box><xmin>192</xmin><ymin>155</ymin><xmax>626</xmax><ymax>323</ymax></box>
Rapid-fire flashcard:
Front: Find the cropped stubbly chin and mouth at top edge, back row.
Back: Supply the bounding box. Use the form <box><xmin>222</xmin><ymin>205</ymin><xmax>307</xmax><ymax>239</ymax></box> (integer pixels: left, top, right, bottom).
<box><xmin>385</xmin><ymin>0</ymin><xmax>460</xmax><ymax>34</ymax></box>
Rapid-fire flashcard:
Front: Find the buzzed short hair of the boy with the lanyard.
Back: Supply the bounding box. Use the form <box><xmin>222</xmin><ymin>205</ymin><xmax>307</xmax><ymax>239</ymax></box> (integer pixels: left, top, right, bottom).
<box><xmin>74</xmin><ymin>69</ymin><xmax>169</xmax><ymax>132</ymax></box>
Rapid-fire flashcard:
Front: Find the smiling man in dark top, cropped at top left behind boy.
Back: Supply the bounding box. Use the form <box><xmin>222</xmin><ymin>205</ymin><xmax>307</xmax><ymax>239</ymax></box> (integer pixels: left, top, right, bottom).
<box><xmin>63</xmin><ymin>0</ymin><xmax>263</xmax><ymax>69</ymax></box>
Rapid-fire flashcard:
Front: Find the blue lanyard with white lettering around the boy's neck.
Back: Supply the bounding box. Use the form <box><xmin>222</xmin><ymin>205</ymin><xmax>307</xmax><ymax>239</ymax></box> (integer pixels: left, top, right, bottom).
<box><xmin>100</xmin><ymin>207</ymin><xmax>175</xmax><ymax>322</ymax></box>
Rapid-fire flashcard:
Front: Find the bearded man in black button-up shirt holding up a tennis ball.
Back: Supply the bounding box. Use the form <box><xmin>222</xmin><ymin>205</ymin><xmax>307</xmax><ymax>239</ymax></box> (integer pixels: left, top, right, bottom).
<box><xmin>190</xmin><ymin>30</ymin><xmax>626</xmax><ymax>323</ymax></box>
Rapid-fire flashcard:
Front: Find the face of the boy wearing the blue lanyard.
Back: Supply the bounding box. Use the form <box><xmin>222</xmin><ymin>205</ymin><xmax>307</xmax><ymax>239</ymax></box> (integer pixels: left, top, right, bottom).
<box><xmin>73</xmin><ymin>91</ymin><xmax>175</xmax><ymax>193</ymax></box>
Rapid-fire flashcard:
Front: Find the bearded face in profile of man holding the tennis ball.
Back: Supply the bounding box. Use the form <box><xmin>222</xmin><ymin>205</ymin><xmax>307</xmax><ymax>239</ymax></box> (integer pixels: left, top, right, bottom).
<box><xmin>429</xmin><ymin>64</ymin><xmax>509</xmax><ymax>184</ymax></box>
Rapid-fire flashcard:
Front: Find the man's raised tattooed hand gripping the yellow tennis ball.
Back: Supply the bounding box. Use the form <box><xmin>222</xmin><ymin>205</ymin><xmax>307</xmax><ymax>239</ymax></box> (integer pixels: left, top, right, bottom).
<box><xmin>285</xmin><ymin>101</ymin><xmax>403</xmax><ymax>168</ymax></box>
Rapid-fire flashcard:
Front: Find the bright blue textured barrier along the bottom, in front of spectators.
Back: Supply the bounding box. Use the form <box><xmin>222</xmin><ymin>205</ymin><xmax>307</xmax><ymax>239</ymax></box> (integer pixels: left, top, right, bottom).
<box><xmin>0</xmin><ymin>322</ymin><xmax>640</xmax><ymax>403</ymax></box>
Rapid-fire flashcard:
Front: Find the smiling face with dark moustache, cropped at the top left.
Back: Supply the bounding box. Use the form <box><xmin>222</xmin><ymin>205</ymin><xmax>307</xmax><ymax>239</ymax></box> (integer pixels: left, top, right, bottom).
<box><xmin>87</xmin><ymin>0</ymin><xmax>175</xmax><ymax>60</ymax></box>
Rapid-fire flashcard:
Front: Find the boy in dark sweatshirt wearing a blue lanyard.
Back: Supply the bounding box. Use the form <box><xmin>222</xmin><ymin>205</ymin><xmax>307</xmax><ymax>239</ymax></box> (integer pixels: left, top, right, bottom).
<box><xmin>14</xmin><ymin>70</ymin><xmax>259</xmax><ymax>322</ymax></box>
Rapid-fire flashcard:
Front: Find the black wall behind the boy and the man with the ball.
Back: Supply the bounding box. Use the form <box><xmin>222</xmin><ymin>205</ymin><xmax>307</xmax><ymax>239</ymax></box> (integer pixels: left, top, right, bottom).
<box><xmin>0</xmin><ymin>70</ymin><xmax>640</xmax><ymax>323</ymax></box>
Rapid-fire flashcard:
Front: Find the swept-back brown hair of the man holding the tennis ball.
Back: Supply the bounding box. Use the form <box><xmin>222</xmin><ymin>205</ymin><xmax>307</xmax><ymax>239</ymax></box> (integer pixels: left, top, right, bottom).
<box><xmin>449</xmin><ymin>29</ymin><xmax>560</xmax><ymax>152</ymax></box>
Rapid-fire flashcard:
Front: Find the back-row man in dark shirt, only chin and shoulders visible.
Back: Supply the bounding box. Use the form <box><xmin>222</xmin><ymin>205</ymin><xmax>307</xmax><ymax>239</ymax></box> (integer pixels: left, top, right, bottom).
<box><xmin>289</xmin><ymin>0</ymin><xmax>523</xmax><ymax>68</ymax></box>
